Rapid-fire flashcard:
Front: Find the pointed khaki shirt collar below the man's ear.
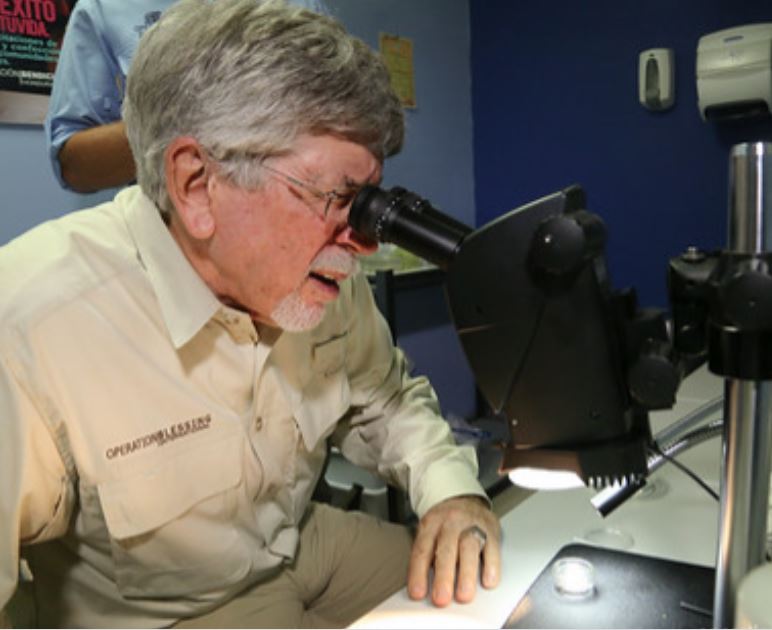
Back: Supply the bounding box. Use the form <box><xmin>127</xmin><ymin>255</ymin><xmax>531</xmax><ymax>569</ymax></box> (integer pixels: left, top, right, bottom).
<box><xmin>118</xmin><ymin>186</ymin><xmax>222</xmax><ymax>348</ymax></box>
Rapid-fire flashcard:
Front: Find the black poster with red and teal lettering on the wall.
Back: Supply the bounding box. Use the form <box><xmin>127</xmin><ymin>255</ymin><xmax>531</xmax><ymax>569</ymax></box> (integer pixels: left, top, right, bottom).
<box><xmin>0</xmin><ymin>0</ymin><xmax>77</xmax><ymax>124</ymax></box>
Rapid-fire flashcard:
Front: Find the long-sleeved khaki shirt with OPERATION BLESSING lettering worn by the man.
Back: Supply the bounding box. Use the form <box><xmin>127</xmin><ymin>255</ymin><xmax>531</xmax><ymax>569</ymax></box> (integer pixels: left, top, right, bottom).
<box><xmin>0</xmin><ymin>187</ymin><xmax>484</xmax><ymax>627</ymax></box>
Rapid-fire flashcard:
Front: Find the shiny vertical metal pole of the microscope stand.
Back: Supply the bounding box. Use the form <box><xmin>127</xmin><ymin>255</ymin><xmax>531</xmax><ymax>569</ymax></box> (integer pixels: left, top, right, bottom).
<box><xmin>713</xmin><ymin>142</ymin><xmax>772</xmax><ymax>628</ymax></box>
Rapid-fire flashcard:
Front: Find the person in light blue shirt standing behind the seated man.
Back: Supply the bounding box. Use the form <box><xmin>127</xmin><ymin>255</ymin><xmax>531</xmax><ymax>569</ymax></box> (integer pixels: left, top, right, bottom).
<box><xmin>45</xmin><ymin>0</ymin><xmax>328</xmax><ymax>192</ymax></box>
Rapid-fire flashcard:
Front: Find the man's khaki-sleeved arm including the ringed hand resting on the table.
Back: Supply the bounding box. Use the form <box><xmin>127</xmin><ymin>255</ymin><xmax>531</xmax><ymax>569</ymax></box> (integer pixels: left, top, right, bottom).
<box><xmin>333</xmin><ymin>276</ymin><xmax>501</xmax><ymax>606</ymax></box>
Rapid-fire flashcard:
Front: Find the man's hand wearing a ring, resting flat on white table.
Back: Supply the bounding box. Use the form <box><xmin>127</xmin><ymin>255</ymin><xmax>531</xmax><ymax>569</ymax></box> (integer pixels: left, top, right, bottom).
<box><xmin>407</xmin><ymin>496</ymin><xmax>501</xmax><ymax>606</ymax></box>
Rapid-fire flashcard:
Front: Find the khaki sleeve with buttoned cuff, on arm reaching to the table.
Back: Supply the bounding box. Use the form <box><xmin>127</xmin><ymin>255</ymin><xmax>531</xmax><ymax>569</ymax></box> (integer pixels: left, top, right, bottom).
<box><xmin>333</xmin><ymin>274</ymin><xmax>486</xmax><ymax>517</ymax></box>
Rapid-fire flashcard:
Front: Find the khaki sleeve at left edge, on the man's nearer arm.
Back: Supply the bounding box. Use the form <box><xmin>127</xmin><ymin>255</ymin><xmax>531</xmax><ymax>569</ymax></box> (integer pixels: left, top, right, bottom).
<box><xmin>0</xmin><ymin>361</ymin><xmax>74</xmax><ymax>611</ymax></box>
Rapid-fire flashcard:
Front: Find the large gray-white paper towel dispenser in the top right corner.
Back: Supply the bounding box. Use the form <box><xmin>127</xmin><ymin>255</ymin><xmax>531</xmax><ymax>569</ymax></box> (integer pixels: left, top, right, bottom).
<box><xmin>697</xmin><ymin>23</ymin><xmax>772</xmax><ymax>121</ymax></box>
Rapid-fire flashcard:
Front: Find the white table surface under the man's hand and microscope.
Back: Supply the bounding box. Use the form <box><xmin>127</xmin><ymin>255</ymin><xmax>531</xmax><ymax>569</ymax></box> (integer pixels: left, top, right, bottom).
<box><xmin>352</xmin><ymin>368</ymin><xmax>723</xmax><ymax>628</ymax></box>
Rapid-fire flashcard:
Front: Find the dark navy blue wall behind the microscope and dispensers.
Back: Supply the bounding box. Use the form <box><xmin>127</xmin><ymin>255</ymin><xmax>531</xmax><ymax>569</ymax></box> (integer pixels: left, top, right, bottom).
<box><xmin>470</xmin><ymin>0</ymin><xmax>772</xmax><ymax>306</ymax></box>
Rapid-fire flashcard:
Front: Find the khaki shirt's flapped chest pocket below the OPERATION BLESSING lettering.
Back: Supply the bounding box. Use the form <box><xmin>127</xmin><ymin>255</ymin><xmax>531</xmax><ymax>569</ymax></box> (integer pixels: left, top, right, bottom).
<box><xmin>98</xmin><ymin>434</ymin><xmax>250</xmax><ymax>599</ymax></box>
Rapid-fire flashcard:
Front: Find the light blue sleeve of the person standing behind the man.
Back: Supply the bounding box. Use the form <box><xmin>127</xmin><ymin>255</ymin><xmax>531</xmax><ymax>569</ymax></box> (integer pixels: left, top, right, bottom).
<box><xmin>45</xmin><ymin>0</ymin><xmax>126</xmax><ymax>188</ymax></box>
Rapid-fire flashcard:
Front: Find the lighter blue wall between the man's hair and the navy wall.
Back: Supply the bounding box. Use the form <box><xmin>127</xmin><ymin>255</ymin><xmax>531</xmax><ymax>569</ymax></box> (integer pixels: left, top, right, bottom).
<box><xmin>325</xmin><ymin>0</ymin><xmax>475</xmax><ymax>225</ymax></box>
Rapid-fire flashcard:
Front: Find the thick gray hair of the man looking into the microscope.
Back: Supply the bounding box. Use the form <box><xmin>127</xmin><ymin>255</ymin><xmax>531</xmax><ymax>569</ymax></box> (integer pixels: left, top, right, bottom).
<box><xmin>123</xmin><ymin>0</ymin><xmax>404</xmax><ymax>213</ymax></box>
